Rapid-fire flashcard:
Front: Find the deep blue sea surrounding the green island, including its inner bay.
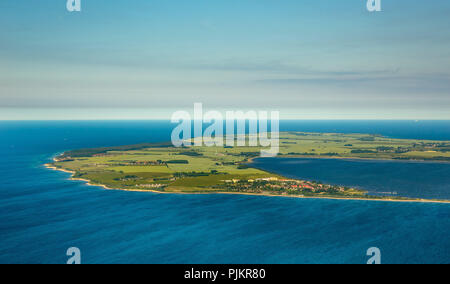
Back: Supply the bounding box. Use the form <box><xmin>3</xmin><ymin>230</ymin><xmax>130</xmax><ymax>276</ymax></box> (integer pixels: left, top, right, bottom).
<box><xmin>0</xmin><ymin>121</ymin><xmax>450</xmax><ymax>263</ymax></box>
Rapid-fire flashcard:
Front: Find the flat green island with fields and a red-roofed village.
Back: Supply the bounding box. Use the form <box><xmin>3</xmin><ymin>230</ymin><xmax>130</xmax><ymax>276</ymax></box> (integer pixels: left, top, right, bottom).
<box><xmin>46</xmin><ymin>132</ymin><xmax>450</xmax><ymax>202</ymax></box>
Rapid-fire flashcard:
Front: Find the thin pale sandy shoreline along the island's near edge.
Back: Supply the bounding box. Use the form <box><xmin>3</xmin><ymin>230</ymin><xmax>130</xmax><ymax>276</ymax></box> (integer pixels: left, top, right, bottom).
<box><xmin>44</xmin><ymin>162</ymin><xmax>450</xmax><ymax>204</ymax></box>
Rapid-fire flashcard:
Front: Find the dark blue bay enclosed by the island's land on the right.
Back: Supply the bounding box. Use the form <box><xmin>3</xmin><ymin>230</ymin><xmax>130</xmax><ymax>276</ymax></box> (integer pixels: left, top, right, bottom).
<box><xmin>253</xmin><ymin>158</ymin><xmax>450</xmax><ymax>200</ymax></box>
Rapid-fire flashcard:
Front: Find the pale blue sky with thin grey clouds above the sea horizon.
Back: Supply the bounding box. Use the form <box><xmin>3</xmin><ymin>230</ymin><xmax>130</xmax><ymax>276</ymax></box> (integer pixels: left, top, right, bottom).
<box><xmin>0</xmin><ymin>0</ymin><xmax>450</xmax><ymax>120</ymax></box>
